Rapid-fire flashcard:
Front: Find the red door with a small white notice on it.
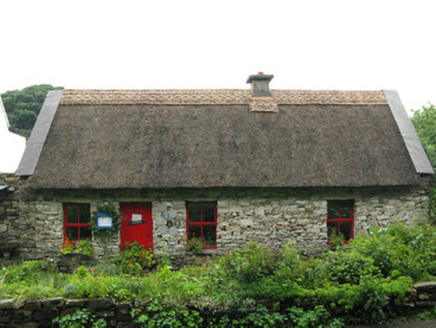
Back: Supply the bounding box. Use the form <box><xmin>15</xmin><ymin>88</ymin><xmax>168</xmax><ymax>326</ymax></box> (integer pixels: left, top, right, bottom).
<box><xmin>120</xmin><ymin>202</ymin><xmax>153</xmax><ymax>249</ymax></box>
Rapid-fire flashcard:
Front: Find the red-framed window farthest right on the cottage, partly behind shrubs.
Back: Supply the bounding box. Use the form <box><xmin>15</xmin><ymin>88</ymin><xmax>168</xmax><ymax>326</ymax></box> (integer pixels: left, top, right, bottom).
<box><xmin>327</xmin><ymin>200</ymin><xmax>354</xmax><ymax>241</ymax></box>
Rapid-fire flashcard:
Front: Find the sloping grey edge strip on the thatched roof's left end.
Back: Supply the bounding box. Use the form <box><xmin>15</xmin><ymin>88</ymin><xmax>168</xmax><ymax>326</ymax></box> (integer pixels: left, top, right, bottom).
<box><xmin>15</xmin><ymin>90</ymin><xmax>63</xmax><ymax>176</ymax></box>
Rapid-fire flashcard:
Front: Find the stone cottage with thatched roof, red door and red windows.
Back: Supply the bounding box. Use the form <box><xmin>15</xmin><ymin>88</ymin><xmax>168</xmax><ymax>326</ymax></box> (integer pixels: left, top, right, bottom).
<box><xmin>11</xmin><ymin>75</ymin><xmax>433</xmax><ymax>257</ymax></box>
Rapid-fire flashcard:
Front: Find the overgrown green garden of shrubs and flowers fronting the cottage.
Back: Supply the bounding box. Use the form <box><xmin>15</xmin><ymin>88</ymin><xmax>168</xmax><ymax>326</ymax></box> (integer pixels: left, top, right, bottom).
<box><xmin>0</xmin><ymin>224</ymin><xmax>436</xmax><ymax>327</ymax></box>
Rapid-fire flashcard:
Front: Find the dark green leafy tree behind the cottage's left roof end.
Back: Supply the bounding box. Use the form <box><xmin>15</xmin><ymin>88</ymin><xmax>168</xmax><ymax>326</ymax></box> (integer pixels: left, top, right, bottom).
<box><xmin>1</xmin><ymin>84</ymin><xmax>62</xmax><ymax>137</ymax></box>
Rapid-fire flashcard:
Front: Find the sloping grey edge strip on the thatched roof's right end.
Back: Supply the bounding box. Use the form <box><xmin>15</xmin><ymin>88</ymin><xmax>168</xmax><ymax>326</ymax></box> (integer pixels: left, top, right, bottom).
<box><xmin>383</xmin><ymin>90</ymin><xmax>434</xmax><ymax>174</ymax></box>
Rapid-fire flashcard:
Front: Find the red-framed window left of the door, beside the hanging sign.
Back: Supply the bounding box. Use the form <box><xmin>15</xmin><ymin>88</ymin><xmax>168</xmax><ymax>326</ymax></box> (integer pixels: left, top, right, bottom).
<box><xmin>64</xmin><ymin>204</ymin><xmax>92</xmax><ymax>240</ymax></box>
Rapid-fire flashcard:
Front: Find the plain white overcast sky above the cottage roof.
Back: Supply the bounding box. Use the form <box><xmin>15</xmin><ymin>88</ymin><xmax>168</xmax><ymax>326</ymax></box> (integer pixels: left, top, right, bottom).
<box><xmin>0</xmin><ymin>0</ymin><xmax>436</xmax><ymax>110</ymax></box>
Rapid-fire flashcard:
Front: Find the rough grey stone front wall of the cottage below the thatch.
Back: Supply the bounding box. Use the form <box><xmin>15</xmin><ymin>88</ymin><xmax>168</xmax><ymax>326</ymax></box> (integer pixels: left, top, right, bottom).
<box><xmin>9</xmin><ymin>181</ymin><xmax>428</xmax><ymax>259</ymax></box>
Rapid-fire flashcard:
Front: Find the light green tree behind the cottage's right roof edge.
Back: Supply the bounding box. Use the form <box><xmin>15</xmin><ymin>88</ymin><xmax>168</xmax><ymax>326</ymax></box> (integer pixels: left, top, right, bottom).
<box><xmin>412</xmin><ymin>104</ymin><xmax>436</xmax><ymax>223</ymax></box>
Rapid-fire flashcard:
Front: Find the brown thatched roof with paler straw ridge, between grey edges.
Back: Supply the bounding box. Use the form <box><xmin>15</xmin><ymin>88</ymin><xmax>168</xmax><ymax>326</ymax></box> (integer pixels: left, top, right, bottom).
<box><xmin>17</xmin><ymin>90</ymin><xmax>432</xmax><ymax>189</ymax></box>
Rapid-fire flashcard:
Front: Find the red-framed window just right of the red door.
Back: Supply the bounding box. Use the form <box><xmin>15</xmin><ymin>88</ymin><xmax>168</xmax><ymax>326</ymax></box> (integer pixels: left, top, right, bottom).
<box><xmin>186</xmin><ymin>202</ymin><xmax>217</xmax><ymax>248</ymax></box>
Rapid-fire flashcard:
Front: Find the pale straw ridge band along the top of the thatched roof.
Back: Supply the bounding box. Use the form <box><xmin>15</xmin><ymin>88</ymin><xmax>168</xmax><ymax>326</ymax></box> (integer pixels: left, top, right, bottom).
<box><xmin>61</xmin><ymin>89</ymin><xmax>387</xmax><ymax>105</ymax></box>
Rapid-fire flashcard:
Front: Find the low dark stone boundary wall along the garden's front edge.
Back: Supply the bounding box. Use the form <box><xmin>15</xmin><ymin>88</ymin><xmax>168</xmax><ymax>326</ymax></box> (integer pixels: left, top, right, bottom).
<box><xmin>0</xmin><ymin>282</ymin><xmax>436</xmax><ymax>328</ymax></box>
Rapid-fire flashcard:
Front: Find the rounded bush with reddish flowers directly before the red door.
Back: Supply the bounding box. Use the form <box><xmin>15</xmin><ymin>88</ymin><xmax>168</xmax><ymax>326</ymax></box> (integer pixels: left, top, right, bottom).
<box><xmin>116</xmin><ymin>241</ymin><xmax>155</xmax><ymax>275</ymax></box>
